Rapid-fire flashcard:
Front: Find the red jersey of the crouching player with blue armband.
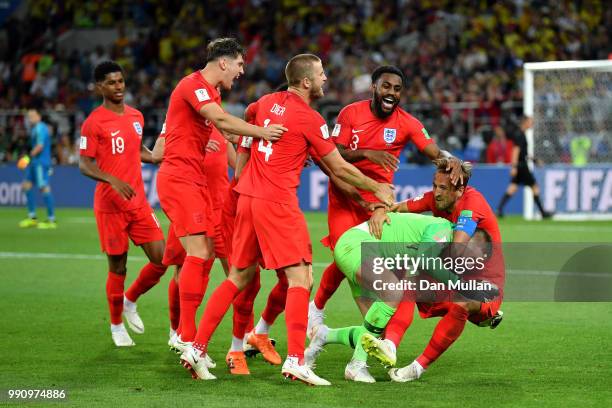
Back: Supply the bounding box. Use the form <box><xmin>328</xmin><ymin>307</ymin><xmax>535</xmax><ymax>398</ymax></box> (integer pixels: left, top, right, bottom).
<box><xmin>406</xmin><ymin>186</ymin><xmax>501</xmax><ymax>242</ymax></box>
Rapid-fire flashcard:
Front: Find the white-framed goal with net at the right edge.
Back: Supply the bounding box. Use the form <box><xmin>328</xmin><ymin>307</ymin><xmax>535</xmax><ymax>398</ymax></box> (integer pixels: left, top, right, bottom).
<box><xmin>523</xmin><ymin>60</ymin><xmax>612</xmax><ymax>220</ymax></box>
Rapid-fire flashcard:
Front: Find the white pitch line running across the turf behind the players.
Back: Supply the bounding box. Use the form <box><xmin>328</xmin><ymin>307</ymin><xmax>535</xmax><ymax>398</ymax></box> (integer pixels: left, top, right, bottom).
<box><xmin>0</xmin><ymin>252</ymin><xmax>612</xmax><ymax>278</ymax></box>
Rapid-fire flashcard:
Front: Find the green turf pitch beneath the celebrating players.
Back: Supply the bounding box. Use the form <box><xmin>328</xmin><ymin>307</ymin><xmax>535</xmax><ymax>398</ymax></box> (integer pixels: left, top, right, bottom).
<box><xmin>0</xmin><ymin>209</ymin><xmax>612</xmax><ymax>407</ymax></box>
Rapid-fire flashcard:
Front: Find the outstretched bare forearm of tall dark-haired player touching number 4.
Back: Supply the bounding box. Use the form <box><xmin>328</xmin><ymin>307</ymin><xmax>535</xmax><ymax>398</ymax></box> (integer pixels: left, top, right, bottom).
<box><xmin>200</xmin><ymin>103</ymin><xmax>287</xmax><ymax>142</ymax></box>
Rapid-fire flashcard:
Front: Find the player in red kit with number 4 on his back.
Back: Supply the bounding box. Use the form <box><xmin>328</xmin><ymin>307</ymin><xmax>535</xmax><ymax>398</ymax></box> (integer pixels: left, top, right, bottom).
<box><xmin>181</xmin><ymin>54</ymin><xmax>393</xmax><ymax>385</ymax></box>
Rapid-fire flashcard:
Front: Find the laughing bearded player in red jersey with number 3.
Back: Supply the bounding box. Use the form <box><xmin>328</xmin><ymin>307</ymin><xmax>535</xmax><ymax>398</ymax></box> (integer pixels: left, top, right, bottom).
<box><xmin>308</xmin><ymin>66</ymin><xmax>460</xmax><ymax>336</ymax></box>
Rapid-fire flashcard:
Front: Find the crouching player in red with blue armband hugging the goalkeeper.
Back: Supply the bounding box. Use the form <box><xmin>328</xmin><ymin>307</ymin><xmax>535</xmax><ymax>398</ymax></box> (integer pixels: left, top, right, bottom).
<box><xmin>366</xmin><ymin>159</ymin><xmax>505</xmax><ymax>382</ymax></box>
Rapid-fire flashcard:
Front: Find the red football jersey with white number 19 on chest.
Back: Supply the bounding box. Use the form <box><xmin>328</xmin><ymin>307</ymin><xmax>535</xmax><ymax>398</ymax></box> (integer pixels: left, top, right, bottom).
<box><xmin>81</xmin><ymin>105</ymin><xmax>147</xmax><ymax>212</ymax></box>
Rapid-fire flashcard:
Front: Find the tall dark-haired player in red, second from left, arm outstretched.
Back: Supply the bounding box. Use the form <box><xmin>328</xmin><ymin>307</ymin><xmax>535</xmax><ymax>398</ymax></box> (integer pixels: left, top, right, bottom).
<box><xmin>157</xmin><ymin>38</ymin><xmax>286</xmax><ymax>342</ymax></box>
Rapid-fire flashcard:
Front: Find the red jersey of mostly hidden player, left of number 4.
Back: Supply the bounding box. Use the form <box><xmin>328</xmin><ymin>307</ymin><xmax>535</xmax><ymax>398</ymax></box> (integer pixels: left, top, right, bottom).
<box><xmin>204</xmin><ymin>126</ymin><xmax>229</xmax><ymax>208</ymax></box>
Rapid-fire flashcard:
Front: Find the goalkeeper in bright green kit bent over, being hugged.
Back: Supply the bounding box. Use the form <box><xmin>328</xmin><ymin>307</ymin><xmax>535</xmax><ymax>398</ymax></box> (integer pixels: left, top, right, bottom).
<box><xmin>304</xmin><ymin>213</ymin><xmax>497</xmax><ymax>383</ymax></box>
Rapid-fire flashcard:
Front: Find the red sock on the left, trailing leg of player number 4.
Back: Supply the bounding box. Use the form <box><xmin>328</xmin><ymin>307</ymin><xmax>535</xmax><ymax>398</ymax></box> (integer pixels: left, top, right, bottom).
<box><xmin>194</xmin><ymin>280</ymin><xmax>240</xmax><ymax>351</ymax></box>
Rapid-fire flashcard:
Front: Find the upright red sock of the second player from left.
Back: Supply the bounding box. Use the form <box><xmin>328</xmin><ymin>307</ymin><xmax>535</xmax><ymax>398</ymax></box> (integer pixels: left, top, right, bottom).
<box><xmin>179</xmin><ymin>256</ymin><xmax>212</xmax><ymax>341</ymax></box>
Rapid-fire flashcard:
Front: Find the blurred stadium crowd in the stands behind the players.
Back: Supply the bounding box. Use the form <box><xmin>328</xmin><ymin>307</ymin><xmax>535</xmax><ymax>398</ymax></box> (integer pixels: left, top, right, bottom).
<box><xmin>0</xmin><ymin>0</ymin><xmax>612</xmax><ymax>164</ymax></box>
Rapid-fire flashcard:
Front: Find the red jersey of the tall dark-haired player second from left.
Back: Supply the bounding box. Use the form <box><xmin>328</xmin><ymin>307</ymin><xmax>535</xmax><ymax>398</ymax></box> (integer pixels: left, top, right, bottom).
<box><xmin>159</xmin><ymin>71</ymin><xmax>221</xmax><ymax>183</ymax></box>
